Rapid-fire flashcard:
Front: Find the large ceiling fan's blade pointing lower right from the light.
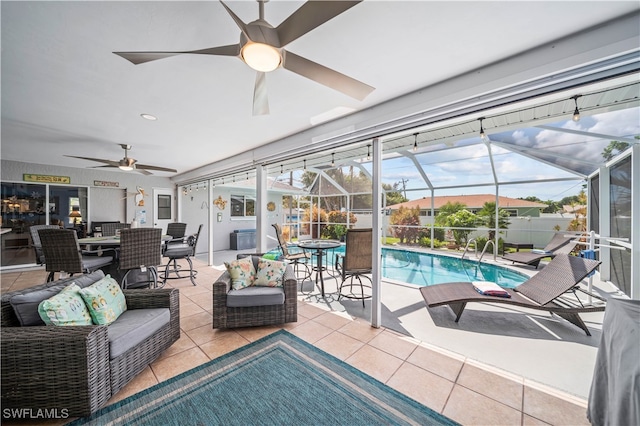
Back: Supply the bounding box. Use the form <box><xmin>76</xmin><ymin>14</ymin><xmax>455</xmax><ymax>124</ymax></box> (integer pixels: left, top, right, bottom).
<box><xmin>282</xmin><ymin>51</ymin><xmax>375</xmax><ymax>101</ymax></box>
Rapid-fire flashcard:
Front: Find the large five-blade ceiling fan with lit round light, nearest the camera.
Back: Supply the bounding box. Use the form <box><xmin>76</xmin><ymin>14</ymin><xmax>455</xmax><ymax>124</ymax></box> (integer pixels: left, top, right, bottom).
<box><xmin>113</xmin><ymin>0</ymin><xmax>374</xmax><ymax>115</ymax></box>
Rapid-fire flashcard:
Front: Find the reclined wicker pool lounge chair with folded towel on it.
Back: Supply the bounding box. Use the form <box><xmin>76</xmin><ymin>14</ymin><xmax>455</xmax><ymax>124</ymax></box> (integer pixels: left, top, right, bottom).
<box><xmin>420</xmin><ymin>254</ymin><xmax>605</xmax><ymax>336</ymax></box>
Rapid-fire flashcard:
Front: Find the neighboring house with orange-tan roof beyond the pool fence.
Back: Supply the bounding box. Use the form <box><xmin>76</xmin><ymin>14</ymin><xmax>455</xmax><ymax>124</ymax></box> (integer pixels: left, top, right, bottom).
<box><xmin>387</xmin><ymin>194</ymin><xmax>547</xmax><ymax>217</ymax></box>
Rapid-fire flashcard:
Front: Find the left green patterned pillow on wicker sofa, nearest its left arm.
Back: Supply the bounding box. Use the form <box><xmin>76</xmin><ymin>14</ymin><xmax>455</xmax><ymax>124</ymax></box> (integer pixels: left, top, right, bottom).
<box><xmin>38</xmin><ymin>283</ymin><xmax>92</xmax><ymax>326</ymax></box>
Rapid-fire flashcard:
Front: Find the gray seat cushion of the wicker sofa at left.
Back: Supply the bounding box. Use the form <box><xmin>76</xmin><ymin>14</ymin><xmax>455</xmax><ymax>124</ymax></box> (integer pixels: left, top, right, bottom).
<box><xmin>108</xmin><ymin>308</ymin><xmax>171</xmax><ymax>359</ymax></box>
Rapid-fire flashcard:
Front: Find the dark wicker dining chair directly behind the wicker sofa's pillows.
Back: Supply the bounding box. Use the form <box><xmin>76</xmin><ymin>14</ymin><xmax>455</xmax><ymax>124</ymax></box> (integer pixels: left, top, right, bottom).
<box><xmin>38</xmin><ymin>228</ymin><xmax>115</xmax><ymax>282</ymax></box>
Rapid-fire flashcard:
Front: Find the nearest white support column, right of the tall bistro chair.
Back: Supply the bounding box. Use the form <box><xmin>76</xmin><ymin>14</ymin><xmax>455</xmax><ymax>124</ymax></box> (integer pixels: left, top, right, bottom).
<box><xmin>371</xmin><ymin>138</ymin><xmax>382</xmax><ymax>328</ymax></box>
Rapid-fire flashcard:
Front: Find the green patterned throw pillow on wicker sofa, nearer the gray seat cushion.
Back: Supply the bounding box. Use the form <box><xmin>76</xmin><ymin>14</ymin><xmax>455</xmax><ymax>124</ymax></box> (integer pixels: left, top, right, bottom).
<box><xmin>80</xmin><ymin>275</ymin><xmax>127</xmax><ymax>325</ymax></box>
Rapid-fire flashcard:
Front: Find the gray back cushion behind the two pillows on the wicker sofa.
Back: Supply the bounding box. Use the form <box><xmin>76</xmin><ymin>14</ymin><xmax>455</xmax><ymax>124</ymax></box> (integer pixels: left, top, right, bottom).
<box><xmin>9</xmin><ymin>271</ymin><xmax>104</xmax><ymax>327</ymax></box>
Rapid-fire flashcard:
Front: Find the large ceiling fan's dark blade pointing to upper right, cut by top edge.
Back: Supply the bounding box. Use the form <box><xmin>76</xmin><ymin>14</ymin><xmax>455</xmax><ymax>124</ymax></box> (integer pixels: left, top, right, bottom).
<box><xmin>276</xmin><ymin>0</ymin><xmax>362</xmax><ymax>47</ymax></box>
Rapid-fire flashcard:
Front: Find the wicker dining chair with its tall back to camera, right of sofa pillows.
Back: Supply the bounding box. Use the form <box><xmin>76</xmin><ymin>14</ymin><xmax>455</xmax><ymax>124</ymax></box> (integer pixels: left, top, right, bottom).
<box><xmin>118</xmin><ymin>228</ymin><xmax>162</xmax><ymax>289</ymax></box>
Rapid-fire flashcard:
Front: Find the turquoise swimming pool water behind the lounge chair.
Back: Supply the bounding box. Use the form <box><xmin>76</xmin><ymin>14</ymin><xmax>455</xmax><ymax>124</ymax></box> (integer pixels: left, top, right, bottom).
<box><xmin>269</xmin><ymin>246</ymin><xmax>529</xmax><ymax>288</ymax></box>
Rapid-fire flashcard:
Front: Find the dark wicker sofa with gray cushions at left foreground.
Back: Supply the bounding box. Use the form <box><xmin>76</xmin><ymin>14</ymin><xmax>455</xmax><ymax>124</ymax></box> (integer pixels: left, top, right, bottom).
<box><xmin>0</xmin><ymin>271</ymin><xmax>180</xmax><ymax>417</ymax></box>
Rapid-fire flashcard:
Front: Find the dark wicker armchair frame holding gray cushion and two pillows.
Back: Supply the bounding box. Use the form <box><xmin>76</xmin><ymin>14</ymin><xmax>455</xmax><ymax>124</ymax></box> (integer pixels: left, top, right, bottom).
<box><xmin>213</xmin><ymin>255</ymin><xmax>298</xmax><ymax>328</ymax></box>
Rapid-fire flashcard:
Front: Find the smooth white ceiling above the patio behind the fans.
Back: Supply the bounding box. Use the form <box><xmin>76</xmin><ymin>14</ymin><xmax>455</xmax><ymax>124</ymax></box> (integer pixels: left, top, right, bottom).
<box><xmin>1</xmin><ymin>0</ymin><xmax>639</xmax><ymax>176</ymax></box>
